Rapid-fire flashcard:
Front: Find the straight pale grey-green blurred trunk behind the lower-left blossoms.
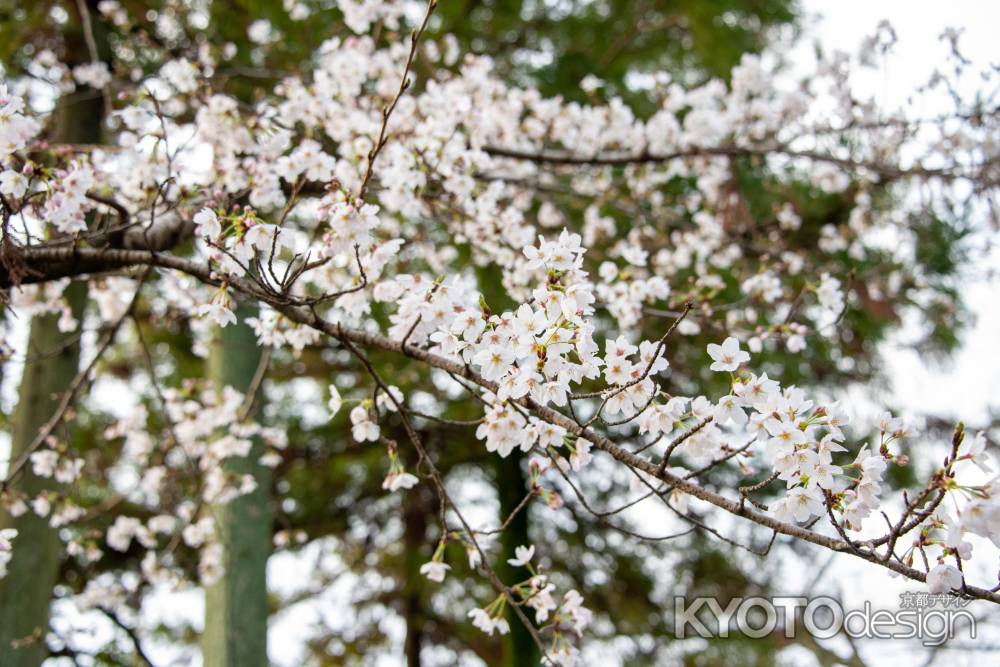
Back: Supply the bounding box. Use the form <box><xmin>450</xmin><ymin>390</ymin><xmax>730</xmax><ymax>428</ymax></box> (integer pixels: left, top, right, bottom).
<box><xmin>202</xmin><ymin>307</ymin><xmax>272</xmax><ymax>667</ymax></box>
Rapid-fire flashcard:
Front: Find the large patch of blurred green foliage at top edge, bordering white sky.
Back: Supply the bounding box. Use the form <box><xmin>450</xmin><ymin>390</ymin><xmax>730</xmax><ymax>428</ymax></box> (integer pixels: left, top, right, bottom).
<box><xmin>438</xmin><ymin>0</ymin><xmax>798</xmax><ymax>106</ymax></box>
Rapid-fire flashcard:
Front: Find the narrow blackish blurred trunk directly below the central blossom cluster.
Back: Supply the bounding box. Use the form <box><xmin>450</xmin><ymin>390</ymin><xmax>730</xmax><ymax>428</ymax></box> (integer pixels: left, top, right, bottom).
<box><xmin>496</xmin><ymin>449</ymin><xmax>541</xmax><ymax>667</ymax></box>
